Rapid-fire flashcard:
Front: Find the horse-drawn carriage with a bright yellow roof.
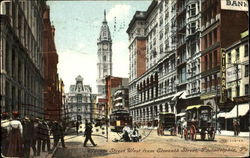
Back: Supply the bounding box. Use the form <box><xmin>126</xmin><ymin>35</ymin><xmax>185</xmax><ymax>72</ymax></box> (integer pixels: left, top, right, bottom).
<box><xmin>184</xmin><ymin>105</ymin><xmax>215</xmax><ymax>140</ymax></box>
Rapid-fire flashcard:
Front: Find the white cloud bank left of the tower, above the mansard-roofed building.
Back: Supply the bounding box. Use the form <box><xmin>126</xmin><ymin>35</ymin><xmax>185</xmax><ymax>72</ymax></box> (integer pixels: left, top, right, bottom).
<box><xmin>58</xmin><ymin>43</ymin><xmax>97</xmax><ymax>92</ymax></box>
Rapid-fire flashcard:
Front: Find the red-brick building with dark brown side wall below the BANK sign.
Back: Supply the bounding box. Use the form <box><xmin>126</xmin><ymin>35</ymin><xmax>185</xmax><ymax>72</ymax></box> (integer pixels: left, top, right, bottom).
<box><xmin>201</xmin><ymin>0</ymin><xmax>248</xmax><ymax>110</ymax></box>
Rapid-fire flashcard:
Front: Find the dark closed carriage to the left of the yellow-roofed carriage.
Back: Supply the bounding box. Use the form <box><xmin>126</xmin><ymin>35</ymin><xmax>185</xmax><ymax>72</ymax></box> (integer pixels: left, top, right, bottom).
<box><xmin>157</xmin><ymin>112</ymin><xmax>175</xmax><ymax>135</ymax></box>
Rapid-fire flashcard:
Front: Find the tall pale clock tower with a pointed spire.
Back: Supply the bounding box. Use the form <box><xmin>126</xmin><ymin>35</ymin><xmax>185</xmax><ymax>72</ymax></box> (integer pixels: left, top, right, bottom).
<box><xmin>96</xmin><ymin>10</ymin><xmax>112</xmax><ymax>97</ymax></box>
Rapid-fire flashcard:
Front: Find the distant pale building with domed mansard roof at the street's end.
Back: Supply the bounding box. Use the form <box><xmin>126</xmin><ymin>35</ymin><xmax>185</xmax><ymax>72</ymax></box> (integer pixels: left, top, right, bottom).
<box><xmin>66</xmin><ymin>75</ymin><xmax>95</xmax><ymax>122</ymax></box>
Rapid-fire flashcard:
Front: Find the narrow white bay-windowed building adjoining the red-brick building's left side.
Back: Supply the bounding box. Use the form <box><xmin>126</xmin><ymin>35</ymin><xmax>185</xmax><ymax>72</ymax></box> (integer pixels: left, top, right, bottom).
<box><xmin>186</xmin><ymin>0</ymin><xmax>201</xmax><ymax>98</ymax></box>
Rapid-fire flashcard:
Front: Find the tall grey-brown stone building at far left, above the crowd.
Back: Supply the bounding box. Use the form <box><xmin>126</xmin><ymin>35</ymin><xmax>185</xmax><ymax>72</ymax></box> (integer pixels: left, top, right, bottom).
<box><xmin>0</xmin><ymin>0</ymin><xmax>46</xmax><ymax>118</ymax></box>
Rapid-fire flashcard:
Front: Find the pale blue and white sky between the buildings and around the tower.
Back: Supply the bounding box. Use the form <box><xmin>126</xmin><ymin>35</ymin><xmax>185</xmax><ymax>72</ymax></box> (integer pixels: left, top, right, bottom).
<box><xmin>47</xmin><ymin>0</ymin><xmax>152</xmax><ymax>93</ymax></box>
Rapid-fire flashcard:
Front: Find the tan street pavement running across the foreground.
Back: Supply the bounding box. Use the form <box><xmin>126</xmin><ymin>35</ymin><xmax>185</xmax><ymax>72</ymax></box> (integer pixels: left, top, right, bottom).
<box><xmin>54</xmin><ymin>129</ymin><xmax>249</xmax><ymax>158</ymax></box>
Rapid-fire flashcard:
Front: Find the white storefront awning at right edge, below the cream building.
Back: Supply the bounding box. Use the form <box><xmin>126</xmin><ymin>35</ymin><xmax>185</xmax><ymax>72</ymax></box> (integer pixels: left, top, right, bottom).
<box><xmin>225</xmin><ymin>103</ymin><xmax>249</xmax><ymax>119</ymax></box>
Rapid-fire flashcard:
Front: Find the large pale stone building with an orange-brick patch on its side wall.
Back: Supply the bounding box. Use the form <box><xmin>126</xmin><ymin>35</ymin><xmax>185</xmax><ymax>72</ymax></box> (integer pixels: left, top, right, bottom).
<box><xmin>127</xmin><ymin>0</ymin><xmax>176</xmax><ymax>126</ymax></box>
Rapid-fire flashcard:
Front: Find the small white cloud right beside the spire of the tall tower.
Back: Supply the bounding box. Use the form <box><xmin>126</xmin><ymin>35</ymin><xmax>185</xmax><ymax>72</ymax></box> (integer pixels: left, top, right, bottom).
<box><xmin>107</xmin><ymin>4</ymin><xmax>131</xmax><ymax>21</ymax></box>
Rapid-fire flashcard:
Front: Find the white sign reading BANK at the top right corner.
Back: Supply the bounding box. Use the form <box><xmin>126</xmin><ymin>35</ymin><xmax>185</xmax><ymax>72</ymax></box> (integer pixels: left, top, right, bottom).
<box><xmin>221</xmin><ymin>0</ymin><xmax>248</xmax><ymax>11</ymax></box>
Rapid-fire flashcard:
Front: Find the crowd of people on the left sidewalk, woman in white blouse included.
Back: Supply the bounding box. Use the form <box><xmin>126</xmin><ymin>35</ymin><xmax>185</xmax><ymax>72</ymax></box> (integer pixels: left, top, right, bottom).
<box><xmin>1</xmin><ymin>112</ymin><xmax>65</xmax><ymax>158</ymax></box>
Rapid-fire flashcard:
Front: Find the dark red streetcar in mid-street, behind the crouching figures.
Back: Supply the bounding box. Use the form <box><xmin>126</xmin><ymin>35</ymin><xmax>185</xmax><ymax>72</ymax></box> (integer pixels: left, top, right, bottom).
<box><xmin>109</xmin><ymin>110</ymin><xmax>132</xmax><ymax>133</ymax></box>
